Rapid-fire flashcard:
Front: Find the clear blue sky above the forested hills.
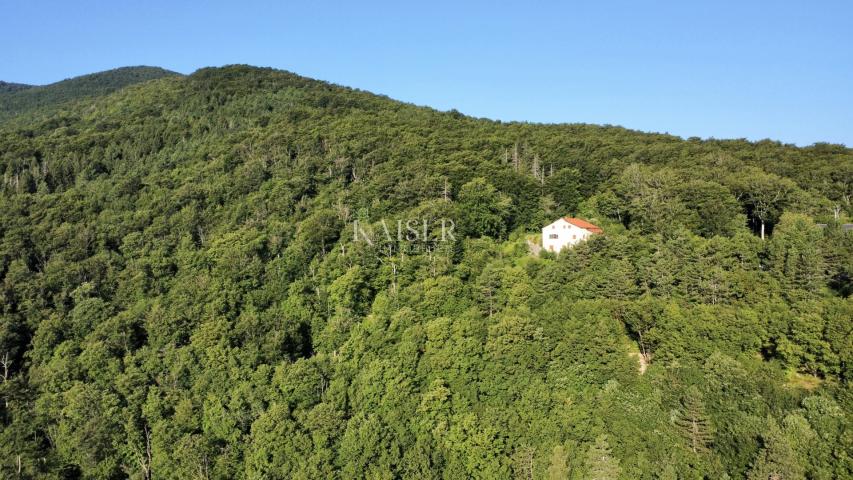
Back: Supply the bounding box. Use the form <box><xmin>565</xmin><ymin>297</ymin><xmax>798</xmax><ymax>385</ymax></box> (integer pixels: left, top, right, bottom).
<box><xmin>0</xmin><ymin>0</ymin><xmax>853</xmax><ymax>146</ymax></box>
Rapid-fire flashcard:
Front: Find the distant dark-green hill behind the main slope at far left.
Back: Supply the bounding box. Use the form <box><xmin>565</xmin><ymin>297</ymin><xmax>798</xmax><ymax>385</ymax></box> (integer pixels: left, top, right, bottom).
<box><xmin>0</xmin><ymin>66</ymin><xmax>180</xmax><ymax>120</ymax></box>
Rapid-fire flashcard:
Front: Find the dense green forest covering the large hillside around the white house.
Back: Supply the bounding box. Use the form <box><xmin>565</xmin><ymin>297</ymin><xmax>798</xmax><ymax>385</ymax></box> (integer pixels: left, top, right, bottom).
<box><xmin>0</xmin><ymin>66</ymin><xmax>853</xmax><ymax>480</ymax></box>
